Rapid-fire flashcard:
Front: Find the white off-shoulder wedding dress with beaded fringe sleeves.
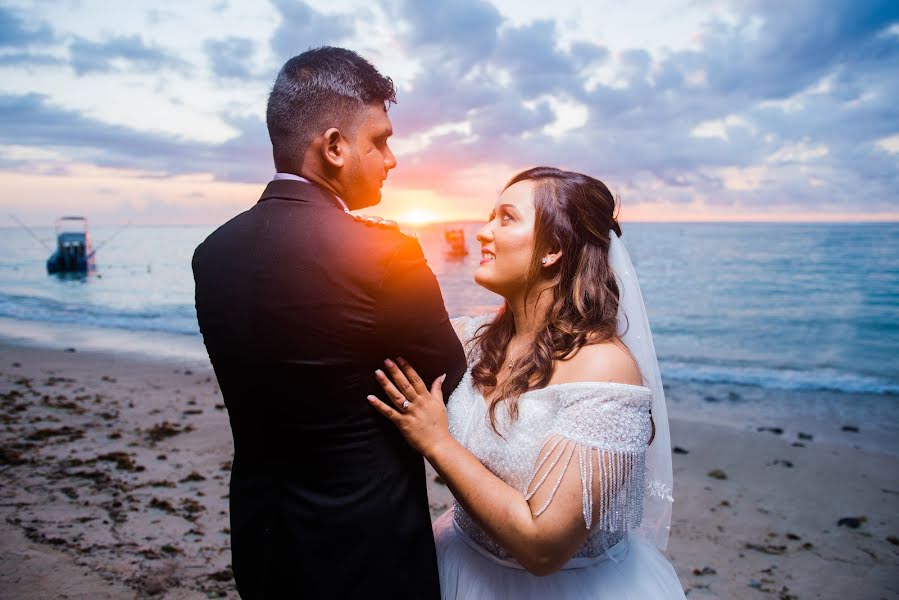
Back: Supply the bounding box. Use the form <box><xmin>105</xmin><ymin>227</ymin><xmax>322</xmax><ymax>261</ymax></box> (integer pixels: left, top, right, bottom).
<box><xmin>434</xmin><ymin>318</ymin><xmax>685</xmax><ymax>600</ymax></box>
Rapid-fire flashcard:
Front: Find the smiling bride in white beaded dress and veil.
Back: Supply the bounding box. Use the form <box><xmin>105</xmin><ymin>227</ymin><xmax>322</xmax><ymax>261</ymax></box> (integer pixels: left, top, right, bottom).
<box><xmin>369</xmin><ymin>167</ymin><xmax>684</xmax><ymax>600</ymax></box>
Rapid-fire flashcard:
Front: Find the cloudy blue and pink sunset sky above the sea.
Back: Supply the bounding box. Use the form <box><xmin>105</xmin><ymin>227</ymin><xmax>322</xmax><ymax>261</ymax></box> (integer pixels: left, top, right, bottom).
<box><xmin>0</xmin><ymin>0</ymin><xmax>899</xmax><ymax>224</ymax></box>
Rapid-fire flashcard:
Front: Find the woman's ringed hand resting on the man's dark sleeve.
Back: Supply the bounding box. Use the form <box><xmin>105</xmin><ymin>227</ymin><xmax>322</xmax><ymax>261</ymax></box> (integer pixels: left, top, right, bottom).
<box><xmin>368</xmin><ymin>358</ymin><xmax>449</xmax><ymax>456</ymax></box>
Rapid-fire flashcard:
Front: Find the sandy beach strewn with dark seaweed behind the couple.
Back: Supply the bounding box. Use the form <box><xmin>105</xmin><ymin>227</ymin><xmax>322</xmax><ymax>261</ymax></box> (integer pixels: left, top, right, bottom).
<box><xmin>0</xmin><ymin>340</ymin><xmax>899</xmax><ymax>600</ymax></box>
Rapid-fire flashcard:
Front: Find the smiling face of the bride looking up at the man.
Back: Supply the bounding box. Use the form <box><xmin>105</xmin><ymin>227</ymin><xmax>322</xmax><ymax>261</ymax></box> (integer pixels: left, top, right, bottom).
<box><xmin>474</xmin><ymin>181</ymin><xmax>536</xmax><ymax>298</ymax></box>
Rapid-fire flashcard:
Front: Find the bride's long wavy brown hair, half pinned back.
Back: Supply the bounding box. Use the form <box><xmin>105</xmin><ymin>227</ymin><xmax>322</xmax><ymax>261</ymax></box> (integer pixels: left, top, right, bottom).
<box><xmin>472</xmin><ymin>167</ymin><xmax>621</xmax><ymax>432</ymax></box>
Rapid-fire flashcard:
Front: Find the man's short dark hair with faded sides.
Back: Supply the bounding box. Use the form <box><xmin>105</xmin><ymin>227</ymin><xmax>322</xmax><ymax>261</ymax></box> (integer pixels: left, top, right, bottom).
<box><xmin>265</xmin><ymin>46</ymin><xmax>396</xmax><ymax>169</ymax></box>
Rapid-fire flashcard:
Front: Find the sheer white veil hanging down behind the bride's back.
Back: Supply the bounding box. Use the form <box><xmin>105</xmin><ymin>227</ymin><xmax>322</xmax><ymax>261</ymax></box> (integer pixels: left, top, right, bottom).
<box><xmin>609</xmin><ymin>231</ymin><xmax>674</xmax><ymax>550</ymax></box>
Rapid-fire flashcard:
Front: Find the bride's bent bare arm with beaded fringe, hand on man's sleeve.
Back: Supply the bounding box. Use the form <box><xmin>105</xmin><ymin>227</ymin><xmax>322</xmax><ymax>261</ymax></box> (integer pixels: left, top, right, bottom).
<box><xmin>369</xmin><ymin>354</ymin><xmax>648</xmax><ymax>575</ymax></box>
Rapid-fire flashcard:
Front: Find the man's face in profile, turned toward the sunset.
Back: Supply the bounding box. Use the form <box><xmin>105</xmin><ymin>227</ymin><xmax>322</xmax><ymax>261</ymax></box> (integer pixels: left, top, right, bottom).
<box><xmin>341</xmin><ymin>105</ymin><xmax>396</xmax><ymax>210</ymax></box>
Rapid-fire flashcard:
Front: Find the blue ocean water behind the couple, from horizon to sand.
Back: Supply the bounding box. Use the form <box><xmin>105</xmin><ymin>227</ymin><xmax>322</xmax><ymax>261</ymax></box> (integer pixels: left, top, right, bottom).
<box><xmin>0</xmin><ymin>223</ymin><xmax>899</xmax><ymax>453</ymax></box>
